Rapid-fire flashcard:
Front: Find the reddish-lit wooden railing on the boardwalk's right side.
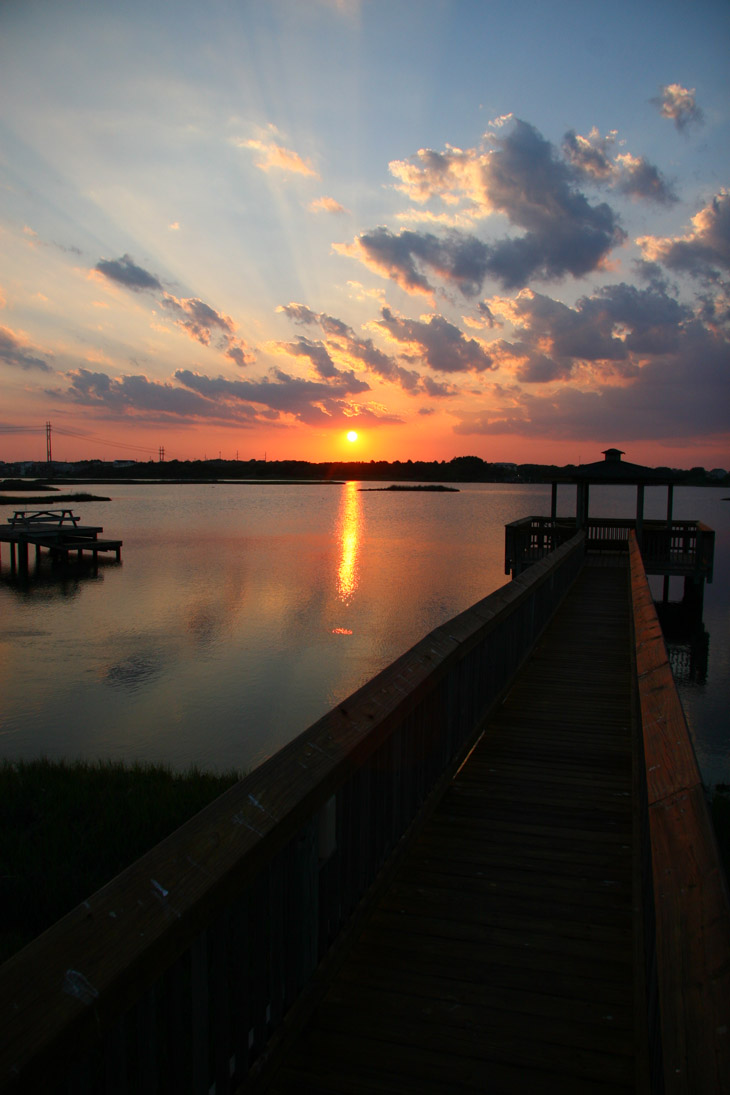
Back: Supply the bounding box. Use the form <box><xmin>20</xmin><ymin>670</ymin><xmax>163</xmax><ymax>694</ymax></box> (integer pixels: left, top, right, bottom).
<box><xmin>629</xmin><ymin>534</ymin><xmax>730</xmax><ymax>1095</ymax></box>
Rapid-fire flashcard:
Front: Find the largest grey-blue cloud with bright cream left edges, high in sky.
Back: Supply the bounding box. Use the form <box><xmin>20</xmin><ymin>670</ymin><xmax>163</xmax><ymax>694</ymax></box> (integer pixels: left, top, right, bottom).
<box><xmin>345</xmin><ymin>118</ymin><xmax>626</xmax><ymax>297</ymax></box>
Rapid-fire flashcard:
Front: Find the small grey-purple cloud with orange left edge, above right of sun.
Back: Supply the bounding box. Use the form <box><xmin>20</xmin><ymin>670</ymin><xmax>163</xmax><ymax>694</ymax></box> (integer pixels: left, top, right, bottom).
<box><xmin>376</xmin><ymin>308</ymin><xmax>495</xmax><ymax>372</ymax></box>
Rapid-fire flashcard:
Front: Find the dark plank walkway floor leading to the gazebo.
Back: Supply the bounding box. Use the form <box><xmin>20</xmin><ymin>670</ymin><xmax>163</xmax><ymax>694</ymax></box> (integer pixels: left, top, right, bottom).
<box><xmin>263</xmin><ymin>561</ymin><xmax>646</xmax><ymax>1095</ymax></box>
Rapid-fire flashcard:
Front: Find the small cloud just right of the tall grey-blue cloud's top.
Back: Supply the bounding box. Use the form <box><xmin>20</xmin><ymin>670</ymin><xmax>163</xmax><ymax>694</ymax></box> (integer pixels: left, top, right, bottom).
<box><xmin>563</xmin><ymin>127</ymin><xmax>677</xmax><ymax>205</ymax></box>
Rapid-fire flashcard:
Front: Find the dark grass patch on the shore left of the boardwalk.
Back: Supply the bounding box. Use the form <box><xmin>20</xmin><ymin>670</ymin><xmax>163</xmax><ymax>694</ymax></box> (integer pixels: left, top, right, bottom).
<box><xmin>0</xmin><ymin>759</ymin><xmax>240</xmax><ymax>963</ymax></box>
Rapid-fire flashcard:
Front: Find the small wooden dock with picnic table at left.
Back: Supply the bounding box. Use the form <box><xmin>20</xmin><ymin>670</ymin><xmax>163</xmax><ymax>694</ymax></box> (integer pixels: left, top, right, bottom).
<box><xmin>0</xmin><ymin>509</ymin><xmax>123</xmax><ymax>573</ymax></box>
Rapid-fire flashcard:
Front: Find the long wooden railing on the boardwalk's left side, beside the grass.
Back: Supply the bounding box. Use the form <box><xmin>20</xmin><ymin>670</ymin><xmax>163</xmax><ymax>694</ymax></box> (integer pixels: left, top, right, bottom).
<box><xmin>0</xmin><ymin>533</ymin><xmax>584</xmax><ymax>1095</ymax></box>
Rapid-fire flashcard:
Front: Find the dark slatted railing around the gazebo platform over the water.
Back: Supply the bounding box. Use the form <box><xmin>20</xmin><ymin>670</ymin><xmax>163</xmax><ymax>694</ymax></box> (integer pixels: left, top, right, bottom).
<box><xmin>505</xmin><ymin>517</ymin><xmax>715</xmax><ymax>581</ymax></box>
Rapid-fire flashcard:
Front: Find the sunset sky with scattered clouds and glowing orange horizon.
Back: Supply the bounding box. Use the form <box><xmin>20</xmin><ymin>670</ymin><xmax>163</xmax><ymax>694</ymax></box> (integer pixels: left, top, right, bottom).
<box><xmin>0</xmin><ymin>0</ymin><xmax>730</xmax><ymax>469</ymax></box>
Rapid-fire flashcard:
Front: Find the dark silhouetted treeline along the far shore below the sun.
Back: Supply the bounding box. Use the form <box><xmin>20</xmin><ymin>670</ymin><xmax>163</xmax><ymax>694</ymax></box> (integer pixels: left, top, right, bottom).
<box><xmin>0</xmin><ymin>457</ymin><xmax>730</xmax><ymax>486</ymax></box>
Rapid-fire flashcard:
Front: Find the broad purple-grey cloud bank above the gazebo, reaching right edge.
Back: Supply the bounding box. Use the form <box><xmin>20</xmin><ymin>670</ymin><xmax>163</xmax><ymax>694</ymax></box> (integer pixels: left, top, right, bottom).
<box><xmin>455</xmin><ymin>284</ymin><xmax>730</xmax><ymax>443</ymax></box>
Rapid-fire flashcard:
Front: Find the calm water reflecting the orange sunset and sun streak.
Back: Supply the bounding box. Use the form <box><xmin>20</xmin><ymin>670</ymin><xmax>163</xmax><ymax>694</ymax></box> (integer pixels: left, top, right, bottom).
<box><xmin>0</xmin><ymin>483</ymin><xmax>730</xmax><ymax>784</ymax></box>
